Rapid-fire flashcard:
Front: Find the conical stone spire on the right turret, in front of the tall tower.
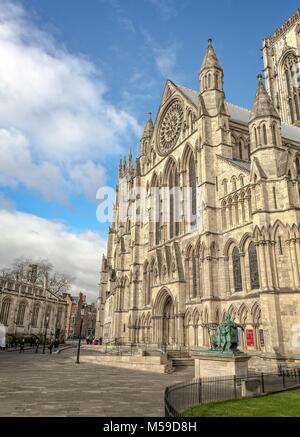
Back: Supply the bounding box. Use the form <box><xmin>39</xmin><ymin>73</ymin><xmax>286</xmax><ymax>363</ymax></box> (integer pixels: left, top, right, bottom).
<box><xmin>250</xmin><ymin>74</ymin><xmax>280</xmax><ymax>123</ymax></box>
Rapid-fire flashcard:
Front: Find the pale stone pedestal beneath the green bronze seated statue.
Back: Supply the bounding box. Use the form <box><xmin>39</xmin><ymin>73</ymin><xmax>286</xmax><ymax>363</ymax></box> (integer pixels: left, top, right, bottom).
<box><xmin>195</xmin><ymin>351</ymin><xmax>250</xmax><ymax>378</ymax></box>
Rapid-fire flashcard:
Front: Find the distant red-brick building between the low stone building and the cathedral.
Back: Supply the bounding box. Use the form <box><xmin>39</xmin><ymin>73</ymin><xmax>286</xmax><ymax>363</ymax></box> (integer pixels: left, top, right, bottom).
<box><xmin>65</xmin><ymin>292</ymin><xmax>97</xmax><ymax>338</ymax></box>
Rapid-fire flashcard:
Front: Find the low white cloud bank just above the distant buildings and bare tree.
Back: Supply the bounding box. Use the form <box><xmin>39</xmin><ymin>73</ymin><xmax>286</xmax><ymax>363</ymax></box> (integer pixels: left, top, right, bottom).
<box><xmin>0</xmin><ymin>210</ymin><xmax>106</xmax><ymax>301</ymax></box>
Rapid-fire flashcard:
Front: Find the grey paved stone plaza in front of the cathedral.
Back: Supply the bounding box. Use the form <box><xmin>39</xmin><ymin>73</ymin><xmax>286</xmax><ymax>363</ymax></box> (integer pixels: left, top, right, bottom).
<box><xmin>0</xmin><ymin>349</ymin><xmax>193</xmax><ymax>417</ymax></box>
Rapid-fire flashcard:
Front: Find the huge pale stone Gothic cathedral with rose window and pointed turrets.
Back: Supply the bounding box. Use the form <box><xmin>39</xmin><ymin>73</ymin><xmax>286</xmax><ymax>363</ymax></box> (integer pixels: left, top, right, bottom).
<box><xmin>96</xmin><ymin>10</ymin><xmax>300</xmax><ymax>369</ymax></box>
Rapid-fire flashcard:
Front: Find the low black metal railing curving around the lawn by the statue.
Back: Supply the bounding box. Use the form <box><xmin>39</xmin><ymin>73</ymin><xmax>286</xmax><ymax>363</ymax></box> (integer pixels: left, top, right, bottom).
<box><xmin>165</xmin><ymin>368</ymin><xmax>300</xmax><ymax>417</ymax></box>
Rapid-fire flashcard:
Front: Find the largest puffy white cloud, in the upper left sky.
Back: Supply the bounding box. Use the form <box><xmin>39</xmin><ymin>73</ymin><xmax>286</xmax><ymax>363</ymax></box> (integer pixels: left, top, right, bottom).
<box><xmin>0</xmin><ymin>0</ymin><xmax>140</xmax><ymax>202</ymax></box>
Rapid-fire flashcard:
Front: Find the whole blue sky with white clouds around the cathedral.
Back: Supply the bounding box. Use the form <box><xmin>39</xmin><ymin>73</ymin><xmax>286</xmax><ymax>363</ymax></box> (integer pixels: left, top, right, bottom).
<box><xmin>0</xmin><ymin>0</ymin><xmax>299</xmax><ymax>296</ymax></box>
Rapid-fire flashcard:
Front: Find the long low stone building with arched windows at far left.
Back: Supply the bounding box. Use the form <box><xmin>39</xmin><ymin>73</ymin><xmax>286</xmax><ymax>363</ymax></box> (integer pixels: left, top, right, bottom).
<box><xmin>0</xmin><ymin>266</ymin><xmax>67</xmax><ymax>340</ymax></box>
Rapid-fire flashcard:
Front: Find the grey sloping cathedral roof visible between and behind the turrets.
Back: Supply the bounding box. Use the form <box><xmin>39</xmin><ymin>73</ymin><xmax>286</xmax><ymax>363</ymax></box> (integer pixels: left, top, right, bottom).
<box><xmin>176</xmin><ymin>85</ymin><xmax>300</xmax><ymax>143</ymax></box>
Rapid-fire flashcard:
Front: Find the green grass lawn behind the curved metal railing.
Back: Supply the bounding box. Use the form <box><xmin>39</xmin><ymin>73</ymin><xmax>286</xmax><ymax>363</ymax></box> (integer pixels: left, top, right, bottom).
<box><xmin>183</xmin><ymin>389</ymin><xmax>300</xmax><ymax>417</ymax></box>
